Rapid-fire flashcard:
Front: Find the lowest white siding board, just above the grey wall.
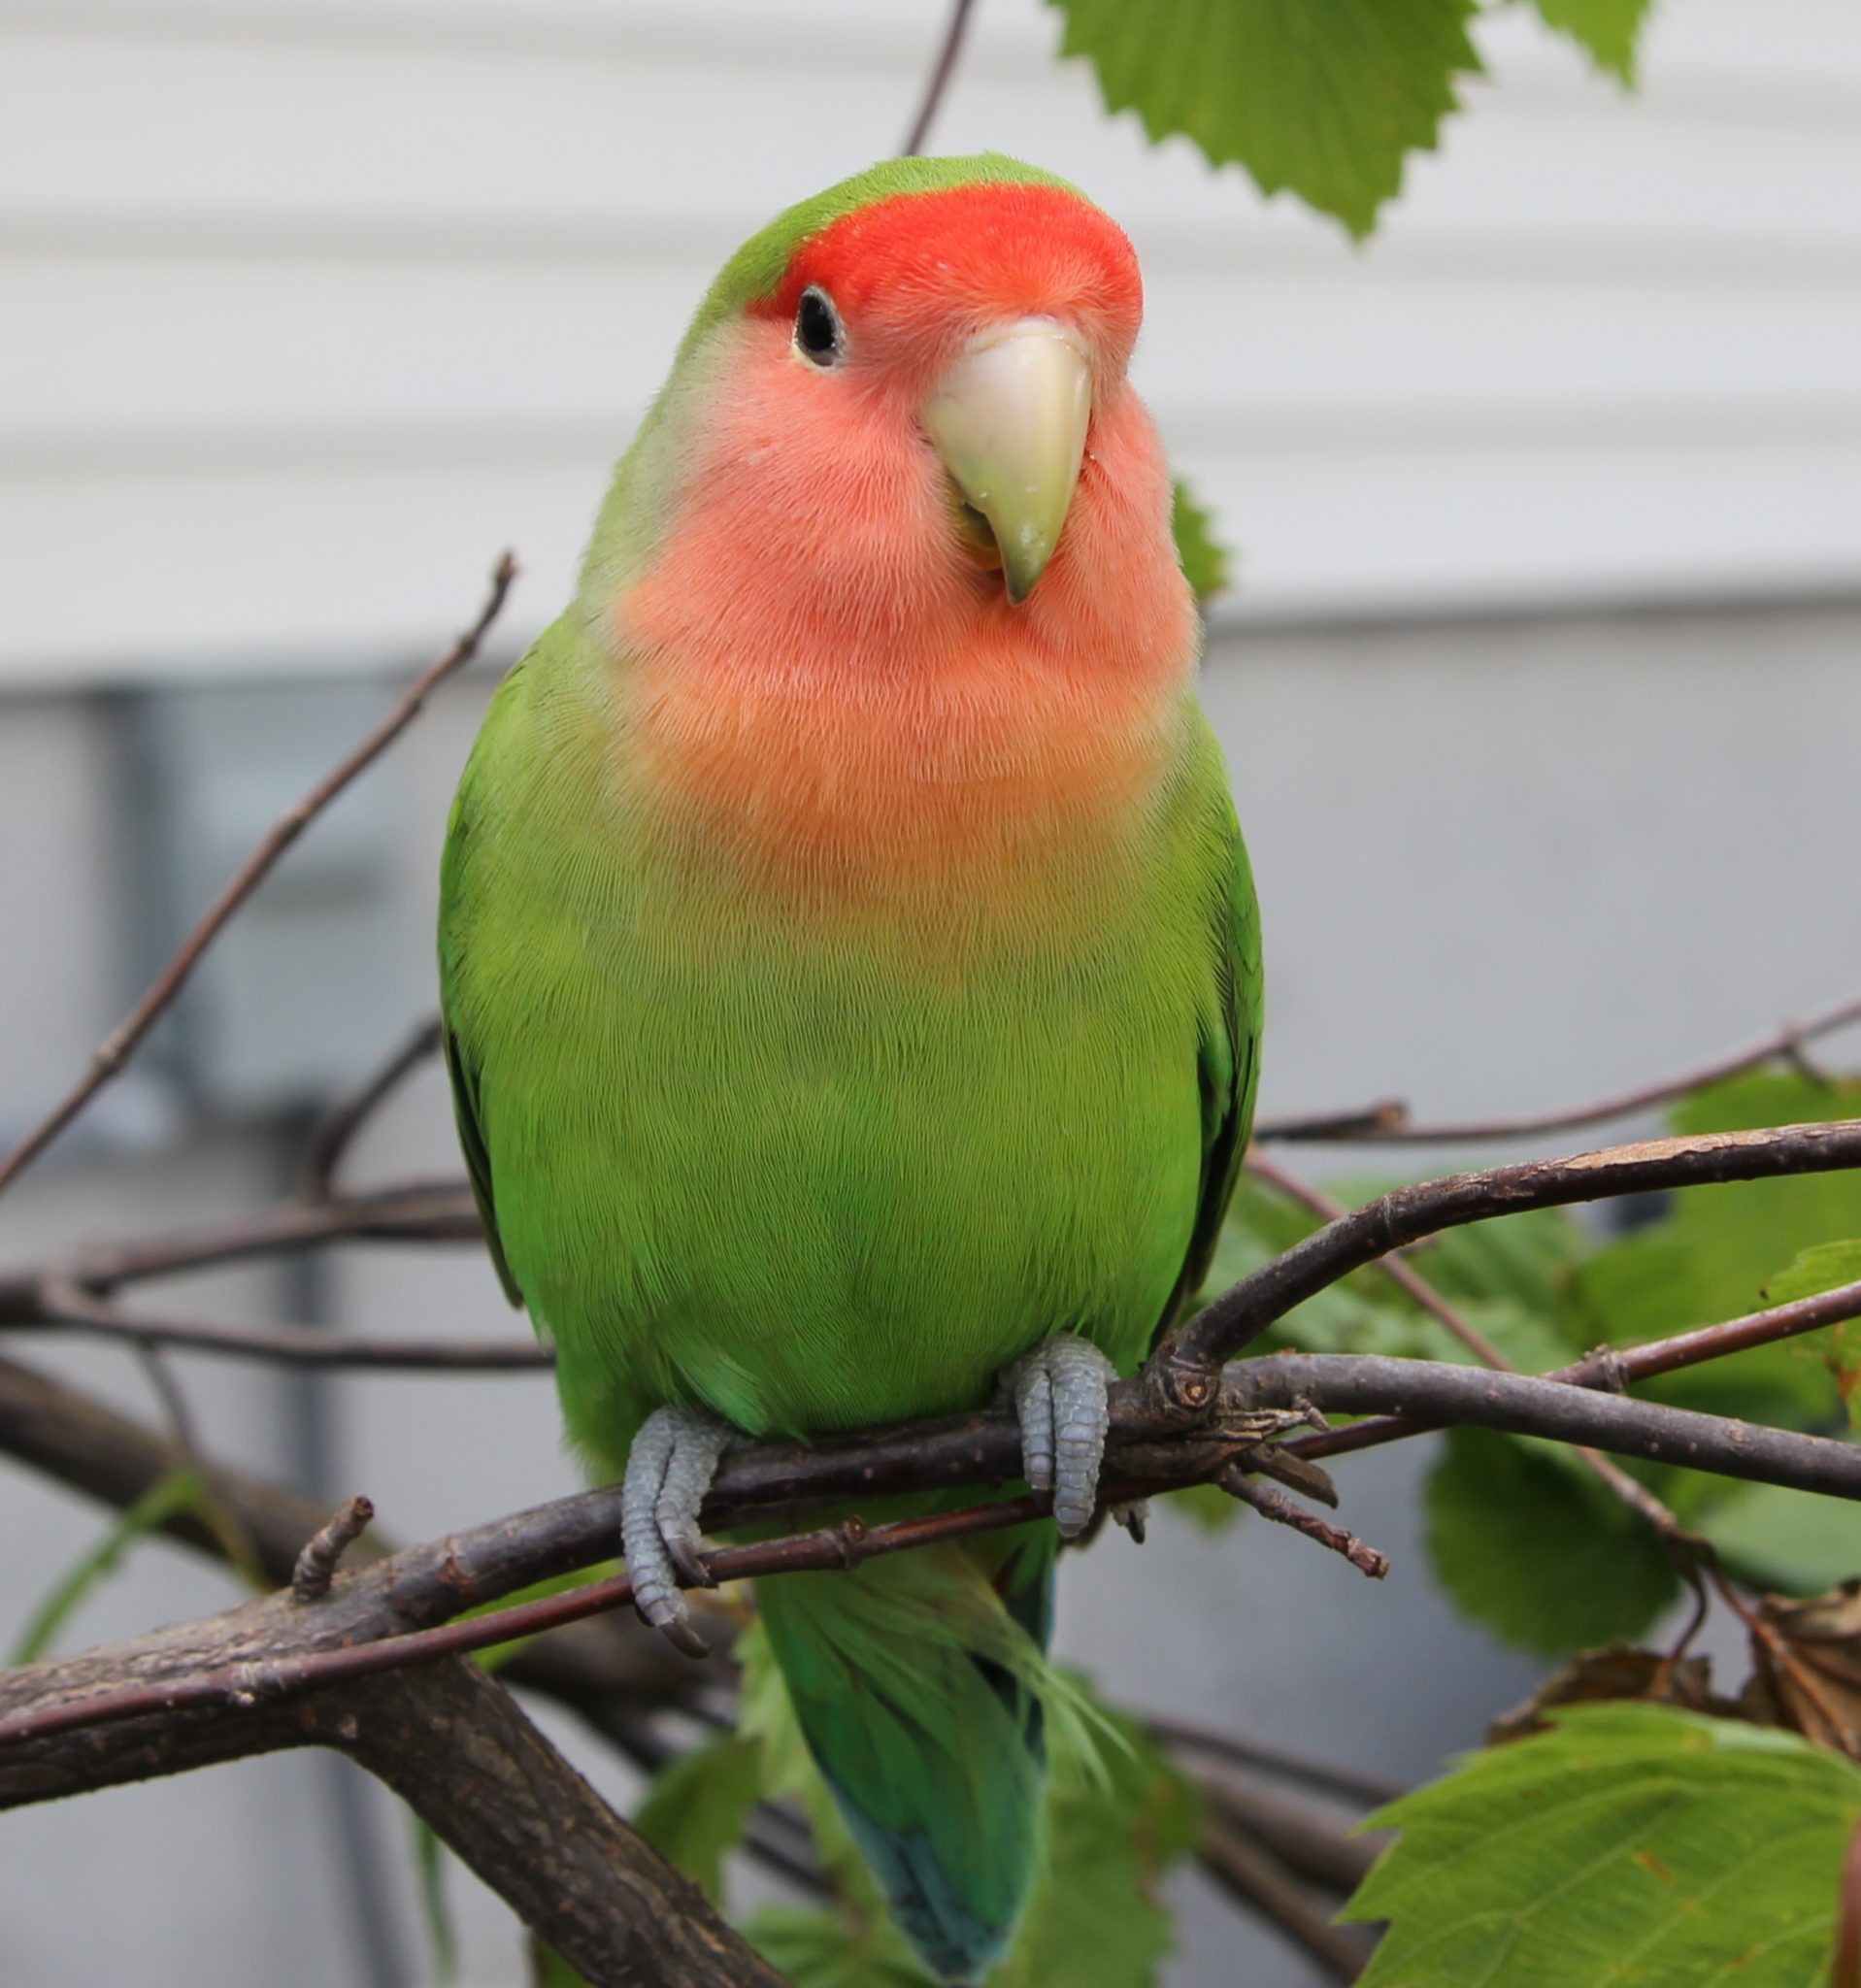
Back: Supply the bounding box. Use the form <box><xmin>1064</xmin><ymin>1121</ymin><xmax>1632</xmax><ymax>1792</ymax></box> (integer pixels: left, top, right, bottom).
<box><xmin>0</xmin><ymin>438</ymin><xmax>1861</xmax><ymax>681</ymax></box>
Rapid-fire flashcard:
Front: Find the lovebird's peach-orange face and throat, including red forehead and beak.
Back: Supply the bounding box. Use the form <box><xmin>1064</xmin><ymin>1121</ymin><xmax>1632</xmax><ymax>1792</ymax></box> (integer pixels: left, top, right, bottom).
<box><xmin>615</xmin><ymin>184</ymin><xmax>1197</xmax><ymax>910</ymax></box>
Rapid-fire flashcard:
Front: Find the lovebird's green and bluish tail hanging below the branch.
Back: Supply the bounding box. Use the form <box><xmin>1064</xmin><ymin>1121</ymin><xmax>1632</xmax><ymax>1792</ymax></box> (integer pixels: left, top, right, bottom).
<box><xmin>757</xmin><ymin>1527</ymin><xmax>1065</xmax><ymax>1982</ymax></box>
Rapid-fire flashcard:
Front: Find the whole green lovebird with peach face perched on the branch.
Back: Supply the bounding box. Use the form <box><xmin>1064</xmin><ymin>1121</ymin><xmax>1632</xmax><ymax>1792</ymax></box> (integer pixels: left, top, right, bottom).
<box><xmin>440</xmin><ymin>155</ymin><xmax>1260</xmax><ymax>1982</ymax></box>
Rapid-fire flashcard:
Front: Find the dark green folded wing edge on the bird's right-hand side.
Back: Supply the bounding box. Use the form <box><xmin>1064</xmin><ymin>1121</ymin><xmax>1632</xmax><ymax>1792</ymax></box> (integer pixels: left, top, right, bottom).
<box><xmin>1159</xmin><ymin>785</ymin><xmax>1263</xmax><ymax>1332</ymax></box>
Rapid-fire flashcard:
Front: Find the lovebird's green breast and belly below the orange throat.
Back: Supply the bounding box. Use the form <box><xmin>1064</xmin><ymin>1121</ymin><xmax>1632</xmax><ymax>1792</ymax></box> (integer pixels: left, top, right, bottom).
<box><xmin>444</xmin><ymin>644</ymin><xmax>1231</xmax><ymax>1455</ymax></box>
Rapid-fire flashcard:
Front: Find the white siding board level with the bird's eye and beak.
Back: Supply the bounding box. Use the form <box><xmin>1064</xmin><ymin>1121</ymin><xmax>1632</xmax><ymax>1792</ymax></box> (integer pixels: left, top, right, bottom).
<box><xmin>0</xmin><ymin>258</ymin><xmax>1861</xmax><ymax>439</ymax></box>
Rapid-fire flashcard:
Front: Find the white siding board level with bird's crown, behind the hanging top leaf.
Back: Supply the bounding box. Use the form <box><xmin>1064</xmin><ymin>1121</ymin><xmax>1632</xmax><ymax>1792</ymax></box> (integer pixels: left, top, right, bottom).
<box><xmin>11</xmin><ymin>34</ymin><xmax>1861</xmax><ymax>252</ymax></box>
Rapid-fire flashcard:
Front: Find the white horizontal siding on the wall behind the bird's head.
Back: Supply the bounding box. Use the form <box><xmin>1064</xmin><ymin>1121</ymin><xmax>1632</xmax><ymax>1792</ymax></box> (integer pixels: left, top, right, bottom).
<box><xmin>0</xmin><ymin>0</ymin><xmax>1861</xmax><ymax>679</ymax></box>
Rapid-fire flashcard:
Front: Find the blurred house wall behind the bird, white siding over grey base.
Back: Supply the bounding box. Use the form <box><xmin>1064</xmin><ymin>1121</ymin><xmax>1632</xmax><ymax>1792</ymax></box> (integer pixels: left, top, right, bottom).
<box><xmin>0</xmin><ymin>0</ymin><xmax>1861</xmax><ymax>1988</ymax></box>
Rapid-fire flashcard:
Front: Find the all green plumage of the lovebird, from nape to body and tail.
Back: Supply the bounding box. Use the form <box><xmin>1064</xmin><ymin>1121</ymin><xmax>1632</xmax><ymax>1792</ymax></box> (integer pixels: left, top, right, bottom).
<box><xmin>440</xmin><ymin>161</ymin><xmax>1260</xmax><ymax>1978</ymax></box>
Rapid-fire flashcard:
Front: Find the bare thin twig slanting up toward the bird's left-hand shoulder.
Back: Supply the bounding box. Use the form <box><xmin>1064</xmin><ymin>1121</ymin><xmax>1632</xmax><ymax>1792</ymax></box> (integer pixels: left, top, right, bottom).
<box><xmin>0</xmin><ymin>552</ymin><xmax>517</xmax><ymax>1191</ymax></box>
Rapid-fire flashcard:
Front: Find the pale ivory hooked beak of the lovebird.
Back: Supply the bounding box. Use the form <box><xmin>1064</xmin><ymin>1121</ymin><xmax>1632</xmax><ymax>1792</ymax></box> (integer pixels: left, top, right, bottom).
<box><xmin>920</xmin><ymin>318</ymin><xmax>1091</xmax><ymax>605</ymax></box>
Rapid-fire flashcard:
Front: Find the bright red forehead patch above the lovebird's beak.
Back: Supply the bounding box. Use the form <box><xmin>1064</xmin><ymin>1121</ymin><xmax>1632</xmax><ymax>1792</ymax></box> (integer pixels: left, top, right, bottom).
<box><xmin>755</xmin><ymin>182</ymin><xmax>1144</xmax><ymax>346</ymax></box>
